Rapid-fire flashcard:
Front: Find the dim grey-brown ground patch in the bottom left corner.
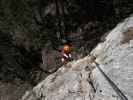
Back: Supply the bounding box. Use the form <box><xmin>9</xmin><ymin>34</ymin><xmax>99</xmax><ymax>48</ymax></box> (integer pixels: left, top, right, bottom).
<box><xmin>0</xmin><ymin>80</ymin><xmax>32</xmax><ymax>100</ymax></box>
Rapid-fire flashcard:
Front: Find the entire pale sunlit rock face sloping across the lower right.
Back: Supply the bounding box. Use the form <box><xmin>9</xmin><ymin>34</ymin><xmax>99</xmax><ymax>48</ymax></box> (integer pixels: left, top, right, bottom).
<box><xmin>20</xmin><ymin>17</ymin><xmax>133</xmax><ymax>100</ymax></box>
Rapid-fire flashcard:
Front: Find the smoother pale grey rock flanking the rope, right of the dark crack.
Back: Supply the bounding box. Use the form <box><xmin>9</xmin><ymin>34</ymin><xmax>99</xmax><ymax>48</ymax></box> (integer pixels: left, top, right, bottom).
<box><xmin>92</xmin><ymin>17</ymin><xmax>133</xmax><ymax>100</ymax></box>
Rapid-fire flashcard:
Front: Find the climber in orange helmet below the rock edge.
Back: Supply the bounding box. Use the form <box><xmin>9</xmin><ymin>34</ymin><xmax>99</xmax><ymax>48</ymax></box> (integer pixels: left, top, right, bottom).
<box><xmin>59</xmin><ymin>42</ymin><xmax>72</xmax><ymax>64</ymax></box>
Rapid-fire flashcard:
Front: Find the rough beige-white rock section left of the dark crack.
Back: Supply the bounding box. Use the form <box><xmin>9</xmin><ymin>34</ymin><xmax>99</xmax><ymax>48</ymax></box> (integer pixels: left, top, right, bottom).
<box><xmin>21</xmin><ymin>57</ymin><xmax>94</xmax><ymax>100</ymax></box>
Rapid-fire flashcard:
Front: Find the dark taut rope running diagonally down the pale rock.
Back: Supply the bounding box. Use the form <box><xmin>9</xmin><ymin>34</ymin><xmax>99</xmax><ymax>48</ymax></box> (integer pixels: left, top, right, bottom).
<box><xmin>92</xmin><ymin>56</ymin><xmax>128</xmax><ymax>100</ymax></box>
